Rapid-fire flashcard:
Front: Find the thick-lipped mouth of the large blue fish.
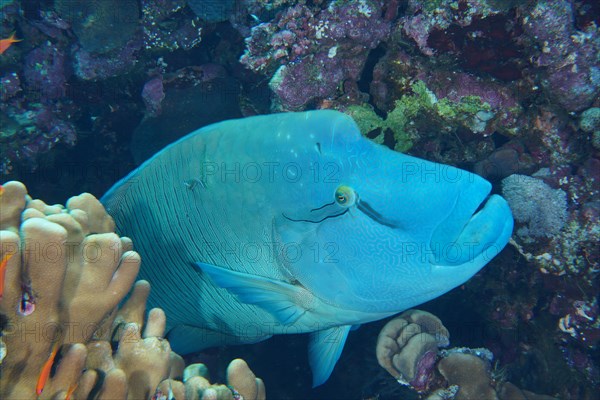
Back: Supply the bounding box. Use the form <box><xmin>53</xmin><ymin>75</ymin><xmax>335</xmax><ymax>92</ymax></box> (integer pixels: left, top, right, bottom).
<box><xmin>430</xmin><ymin>191</ymin><xmax>513</xmax><ymax>270</ymax></box>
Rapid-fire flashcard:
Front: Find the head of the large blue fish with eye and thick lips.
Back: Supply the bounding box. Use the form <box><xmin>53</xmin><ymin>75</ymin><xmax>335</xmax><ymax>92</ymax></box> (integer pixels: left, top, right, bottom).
<box><xmin>273</xmin><ymin>111</ymin><xmax>513</xmax><ymax>314</ymax></box>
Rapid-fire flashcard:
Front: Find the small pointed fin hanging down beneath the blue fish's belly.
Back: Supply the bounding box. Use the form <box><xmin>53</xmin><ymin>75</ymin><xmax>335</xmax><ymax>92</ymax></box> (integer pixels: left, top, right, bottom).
<box><xmin>308</xmin><ymin>325</ymin><xmax>351</xmax><ymax>387</ymax></box>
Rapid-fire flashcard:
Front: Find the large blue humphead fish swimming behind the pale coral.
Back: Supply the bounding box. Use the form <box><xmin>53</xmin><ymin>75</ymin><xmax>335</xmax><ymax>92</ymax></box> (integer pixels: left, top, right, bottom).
<box><xmin>102</xmin><ymin>110</ymin><xmax>513</xmax><ymax>386</ymax></box>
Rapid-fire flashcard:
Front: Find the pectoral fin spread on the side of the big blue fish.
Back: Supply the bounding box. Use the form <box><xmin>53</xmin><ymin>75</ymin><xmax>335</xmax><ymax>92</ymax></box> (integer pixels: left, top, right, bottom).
<box><xmin>196</xmin><ymin>262</ymin><xmax>313</xmax><ymax>325</ymax></box>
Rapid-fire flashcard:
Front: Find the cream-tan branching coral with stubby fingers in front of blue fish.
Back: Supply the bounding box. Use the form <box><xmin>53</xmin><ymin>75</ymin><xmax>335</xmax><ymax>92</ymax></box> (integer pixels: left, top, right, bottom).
<box><xmin>0</xmin><ymin>182</ymin><xmax>265</xmax><ymax>399</ymax></box>
